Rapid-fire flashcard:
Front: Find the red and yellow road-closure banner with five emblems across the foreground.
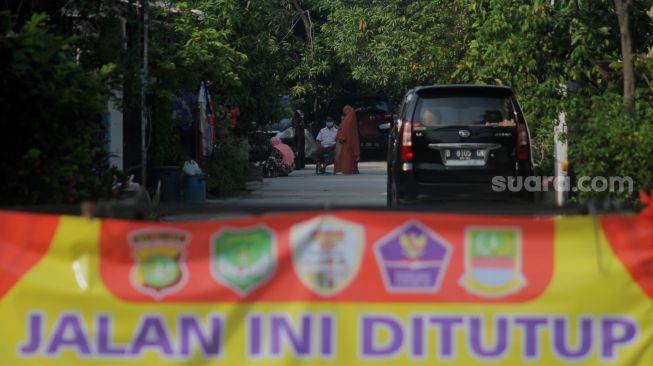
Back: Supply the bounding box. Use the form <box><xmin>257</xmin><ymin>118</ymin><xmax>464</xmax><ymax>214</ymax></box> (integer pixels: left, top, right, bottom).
<box><xmin>0</xmin><ymin>211</ymin><xmax>653</xmax><ymax>366</ymax></box>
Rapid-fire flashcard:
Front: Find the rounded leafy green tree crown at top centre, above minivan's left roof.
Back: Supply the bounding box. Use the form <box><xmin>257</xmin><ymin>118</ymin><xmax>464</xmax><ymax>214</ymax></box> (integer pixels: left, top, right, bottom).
<box><xmin>321</xmin><ymin>0</ymin><xmax>468</xmax><ymax>97</ymax></box>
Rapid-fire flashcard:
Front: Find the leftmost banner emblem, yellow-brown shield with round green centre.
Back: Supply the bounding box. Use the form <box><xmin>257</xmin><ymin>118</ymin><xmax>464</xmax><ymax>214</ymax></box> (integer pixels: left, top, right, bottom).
<box><xmin>128</xmin><ymin>228</ymin><xmax>190</xmax><ymax>300</ymax></box>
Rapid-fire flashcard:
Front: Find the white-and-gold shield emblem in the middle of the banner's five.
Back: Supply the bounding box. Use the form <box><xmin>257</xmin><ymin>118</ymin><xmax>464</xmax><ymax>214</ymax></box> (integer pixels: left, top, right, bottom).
<box><xmin>290</xmin><ymin>215</ymin><xmax>365</xmax><ymax>297</ymax></box>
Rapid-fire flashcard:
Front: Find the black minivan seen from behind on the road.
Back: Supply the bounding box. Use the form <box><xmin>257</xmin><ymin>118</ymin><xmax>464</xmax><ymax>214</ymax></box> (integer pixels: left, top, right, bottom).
<box><xmin>387</xmin><ymin>85</ymin><xmax>533</xmax><ymax>206</ymax></box>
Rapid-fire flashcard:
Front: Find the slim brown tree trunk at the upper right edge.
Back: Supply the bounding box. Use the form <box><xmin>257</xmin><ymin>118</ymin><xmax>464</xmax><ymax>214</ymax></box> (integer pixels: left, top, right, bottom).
<box><xmin>614</xmin><ymin>0</ymin><xmax>635</xmax><ymax>111</ymax></box>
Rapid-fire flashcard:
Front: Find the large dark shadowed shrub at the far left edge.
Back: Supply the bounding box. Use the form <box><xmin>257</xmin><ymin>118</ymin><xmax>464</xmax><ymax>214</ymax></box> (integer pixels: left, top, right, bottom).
<box><xmin>0</xmin><ymin>13</ymin><xmax>113</xmax><ymax>205</ymax></box>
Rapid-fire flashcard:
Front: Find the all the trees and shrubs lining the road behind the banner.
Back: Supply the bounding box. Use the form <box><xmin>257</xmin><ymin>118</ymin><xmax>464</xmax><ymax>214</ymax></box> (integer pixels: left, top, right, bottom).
<box><xmin>0</xmin><ymin>0</ymin><xmax>653</xmax><ymax>204</ymax></box>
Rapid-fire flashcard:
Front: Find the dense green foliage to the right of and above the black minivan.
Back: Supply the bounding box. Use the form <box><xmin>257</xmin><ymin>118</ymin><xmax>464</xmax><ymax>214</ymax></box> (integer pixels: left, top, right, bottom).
<box><xmin>453</xmin><ymin>0</ymin><xmax>653</xmax><ymax>199</ymax></box>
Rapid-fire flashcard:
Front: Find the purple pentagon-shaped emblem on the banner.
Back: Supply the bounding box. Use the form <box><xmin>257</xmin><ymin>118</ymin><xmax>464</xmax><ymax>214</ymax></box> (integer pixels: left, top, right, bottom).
<box><xmin>374</xmin><ymin>221</ymin><xmax>452</xmax><ymax>293</ymax></box>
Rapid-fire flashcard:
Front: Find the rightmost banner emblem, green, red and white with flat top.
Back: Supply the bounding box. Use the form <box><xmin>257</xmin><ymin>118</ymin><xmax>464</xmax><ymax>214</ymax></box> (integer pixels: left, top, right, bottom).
<box><xmin>460</xmin><ymin>227</ymin><xmax>526</xmax><ymax>297</ymax></box>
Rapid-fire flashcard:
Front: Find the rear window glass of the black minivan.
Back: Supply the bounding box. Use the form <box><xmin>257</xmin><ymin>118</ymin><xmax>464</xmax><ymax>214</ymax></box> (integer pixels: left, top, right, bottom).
<box><xmin>415</xmin><ymin>96</ymin><xmax>514</xmax><ymax>127</ymax></box>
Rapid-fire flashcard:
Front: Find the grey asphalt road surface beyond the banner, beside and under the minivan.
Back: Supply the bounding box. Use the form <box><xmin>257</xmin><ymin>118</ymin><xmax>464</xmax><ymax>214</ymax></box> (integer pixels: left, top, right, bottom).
<box><xmin>162</xmin><ymin>161</ymin><xmax>573</xmax><ymax>221</ymax></box>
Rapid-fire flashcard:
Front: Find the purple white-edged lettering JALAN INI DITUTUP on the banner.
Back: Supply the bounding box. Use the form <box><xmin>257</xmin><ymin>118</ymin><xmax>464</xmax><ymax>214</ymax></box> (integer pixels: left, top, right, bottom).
<box><xmin>16</xmin><ymin>311</ymin><xmax>640</xmax><ymax>362</ymax></box>
